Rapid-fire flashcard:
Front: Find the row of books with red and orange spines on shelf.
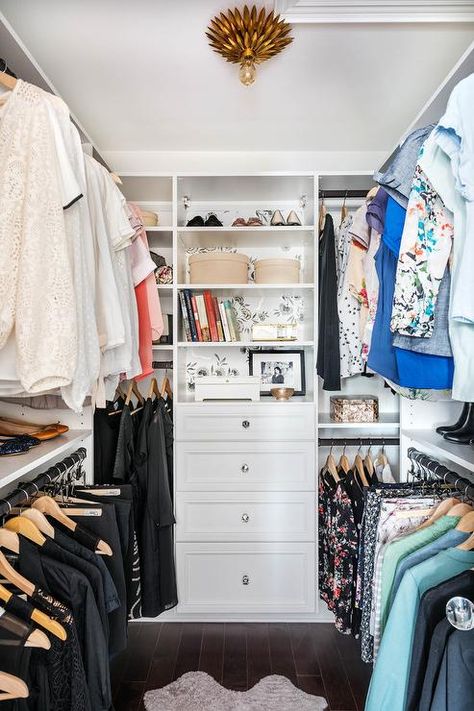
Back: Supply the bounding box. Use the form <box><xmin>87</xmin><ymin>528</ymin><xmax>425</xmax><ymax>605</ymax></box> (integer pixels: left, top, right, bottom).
<box><xmin>179</xmin><ymin>289</ymin><xmax>240</xmax><ymax>343</ymax></box>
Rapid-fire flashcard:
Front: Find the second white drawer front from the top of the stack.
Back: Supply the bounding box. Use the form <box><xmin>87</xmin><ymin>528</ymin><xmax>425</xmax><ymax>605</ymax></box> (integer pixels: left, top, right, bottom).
<box><xmin>176</xmin><ymin>442</ymin><xmax>315</xmax><ymax>491</ymax></box>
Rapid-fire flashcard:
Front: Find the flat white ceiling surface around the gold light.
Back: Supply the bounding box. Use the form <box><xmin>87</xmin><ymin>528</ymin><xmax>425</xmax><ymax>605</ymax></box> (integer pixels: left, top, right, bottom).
<box><xmin>0</xmin><ymin>0</ymin><xmax>474</xmax><ymax>151</ymax></box>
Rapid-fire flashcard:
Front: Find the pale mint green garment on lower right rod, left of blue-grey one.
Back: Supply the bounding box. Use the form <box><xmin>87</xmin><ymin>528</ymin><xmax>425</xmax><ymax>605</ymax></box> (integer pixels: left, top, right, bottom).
<box><xmin>380</xmin><ymin>516</ymin><xmax>460</xmax><ymax>632</ymax></box>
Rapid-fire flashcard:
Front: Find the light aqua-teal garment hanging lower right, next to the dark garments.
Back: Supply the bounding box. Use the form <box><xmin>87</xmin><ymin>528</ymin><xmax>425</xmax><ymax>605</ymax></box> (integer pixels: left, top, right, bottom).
<box><xmin>365</xmin><ymin>548</ymin><xmax>474</xmax><ymax>711</ymax></box>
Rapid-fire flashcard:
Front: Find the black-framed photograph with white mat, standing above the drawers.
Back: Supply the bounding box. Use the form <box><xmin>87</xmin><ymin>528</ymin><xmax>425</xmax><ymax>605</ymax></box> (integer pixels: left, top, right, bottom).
<box><xmin>249</xmin><ymin>348</ymin><xmax>306</xmax><ymax>395</ymax></box>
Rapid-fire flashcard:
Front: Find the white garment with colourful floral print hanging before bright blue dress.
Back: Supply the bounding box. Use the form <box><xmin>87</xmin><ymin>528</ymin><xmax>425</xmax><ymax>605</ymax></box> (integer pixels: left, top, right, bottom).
<box><xmin>390</xmin><ymin>165</ymin><xmax>454</xmax><ymax>338</ymax></box>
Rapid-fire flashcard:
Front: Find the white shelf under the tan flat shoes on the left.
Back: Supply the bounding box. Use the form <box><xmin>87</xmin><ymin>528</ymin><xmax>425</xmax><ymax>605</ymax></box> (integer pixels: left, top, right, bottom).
<box><xmin>0</xmin><ymin>430</ymin><xmax>92</xmax><ymax>487</ymax></box>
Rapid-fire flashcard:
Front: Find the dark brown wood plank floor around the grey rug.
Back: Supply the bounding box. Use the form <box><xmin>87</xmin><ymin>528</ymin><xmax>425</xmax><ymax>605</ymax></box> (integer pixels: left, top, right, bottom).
<box><xmin>112</xmin><ymin>622</ymin><xmax>371</xmax><ymax>711</ymax></box>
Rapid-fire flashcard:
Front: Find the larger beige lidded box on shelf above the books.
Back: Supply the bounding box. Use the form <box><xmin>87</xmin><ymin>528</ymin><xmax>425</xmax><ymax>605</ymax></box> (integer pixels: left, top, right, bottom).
<box><xmin>189</xmin><ymin>251</ymin><xmax>249</xmax><ymax>284</ymax></box>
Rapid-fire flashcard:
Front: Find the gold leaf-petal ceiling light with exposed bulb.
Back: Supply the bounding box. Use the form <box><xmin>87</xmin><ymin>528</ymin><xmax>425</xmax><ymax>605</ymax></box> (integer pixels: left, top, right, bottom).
<box><xmin>206</xmin><ymin>5</ymin><xmax>293</xmax><ymax>86</ymax></box>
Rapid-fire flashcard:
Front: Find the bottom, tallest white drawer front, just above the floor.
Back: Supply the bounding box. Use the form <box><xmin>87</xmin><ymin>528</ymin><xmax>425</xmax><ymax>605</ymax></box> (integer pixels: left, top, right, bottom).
<box><xmin>177</xmin><ymin>543</ymin><xmax>315</xmax><ymax>614</ymax></box>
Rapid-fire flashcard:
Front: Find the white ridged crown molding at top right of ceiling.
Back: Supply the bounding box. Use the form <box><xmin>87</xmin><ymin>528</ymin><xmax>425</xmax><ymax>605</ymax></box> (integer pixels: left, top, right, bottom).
<box><xmin>274</xmin><ymin>0</ymin><xmax>474</xmax><ymax>24</ymax></box>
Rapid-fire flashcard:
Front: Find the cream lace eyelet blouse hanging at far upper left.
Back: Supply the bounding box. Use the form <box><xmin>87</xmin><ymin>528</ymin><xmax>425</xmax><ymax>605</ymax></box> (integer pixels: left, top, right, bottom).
<box><xmin>0</xmin><ymin>80</ymin><xmax>77</xmax><ymax>393</ymax></box>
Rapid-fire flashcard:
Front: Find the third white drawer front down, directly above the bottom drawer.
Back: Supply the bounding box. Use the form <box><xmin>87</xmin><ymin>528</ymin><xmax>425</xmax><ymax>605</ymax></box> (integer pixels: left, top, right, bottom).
<box><xmin>176</xmin><ymin>492</ymin><xmax>316</xmax><ymax>541</ymax></box>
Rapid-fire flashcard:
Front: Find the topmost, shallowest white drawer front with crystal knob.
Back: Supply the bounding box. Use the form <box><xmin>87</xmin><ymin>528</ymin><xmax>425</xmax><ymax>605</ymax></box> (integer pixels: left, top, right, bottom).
<box><xmin>176</xmin><ymin>403</ymin><xmax>314</xmax><ymax>442</ymax></box>
